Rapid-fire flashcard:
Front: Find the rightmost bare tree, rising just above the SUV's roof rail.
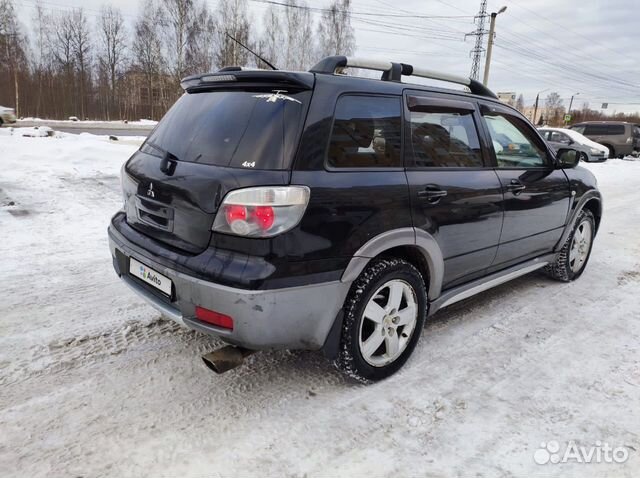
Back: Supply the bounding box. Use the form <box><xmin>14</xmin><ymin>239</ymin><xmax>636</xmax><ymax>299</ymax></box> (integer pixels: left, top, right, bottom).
<box><xmin>318</xmin><ymin>0</ymin><xmax>355</xmax><ymax>57</ymax></box>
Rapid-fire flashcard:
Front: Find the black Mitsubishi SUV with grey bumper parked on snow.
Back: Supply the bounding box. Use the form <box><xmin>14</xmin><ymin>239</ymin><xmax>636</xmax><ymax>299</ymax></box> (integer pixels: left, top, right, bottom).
<box><xmin>109</xmin><ymin>56</ymin><xmax>602</xmax><ymax>381</ymax></box>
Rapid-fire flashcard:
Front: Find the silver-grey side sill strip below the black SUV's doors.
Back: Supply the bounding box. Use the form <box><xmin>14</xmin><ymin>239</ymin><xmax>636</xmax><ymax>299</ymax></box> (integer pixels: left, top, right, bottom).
<box><xmin>428</xmin><ymin>254</ymin><xmax>556</xmax><ymax>315</ymax></box>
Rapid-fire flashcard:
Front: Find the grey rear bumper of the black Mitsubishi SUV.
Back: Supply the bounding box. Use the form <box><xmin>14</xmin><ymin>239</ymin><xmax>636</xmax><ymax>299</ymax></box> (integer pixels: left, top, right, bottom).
<box><xmin>109</xmin><ymin>222</ymin><xmax>351</xmax><ymax>350</ymax></box>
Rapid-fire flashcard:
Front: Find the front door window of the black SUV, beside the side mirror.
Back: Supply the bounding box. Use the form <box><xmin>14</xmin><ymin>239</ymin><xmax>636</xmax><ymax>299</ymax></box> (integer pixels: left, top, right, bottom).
<box><xmin>483</xmin><ymin>114</ymin><xmax>549</xmax><ymax>168</ymax></box>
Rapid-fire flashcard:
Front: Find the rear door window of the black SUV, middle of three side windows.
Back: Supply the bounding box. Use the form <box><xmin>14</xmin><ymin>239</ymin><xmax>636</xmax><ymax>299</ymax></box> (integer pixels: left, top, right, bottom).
<box><xmin>407</xmin><ymin>106</ymin><xmax>483</xmax><ymax>168</ymax></box>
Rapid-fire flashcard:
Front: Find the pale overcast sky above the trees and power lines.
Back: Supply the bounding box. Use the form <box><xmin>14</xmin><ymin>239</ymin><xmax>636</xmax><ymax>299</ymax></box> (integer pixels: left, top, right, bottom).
<box><xmin>15</xmin><ymin>0</ymin><xmax>640</xmax><ymax>112</ymax></box>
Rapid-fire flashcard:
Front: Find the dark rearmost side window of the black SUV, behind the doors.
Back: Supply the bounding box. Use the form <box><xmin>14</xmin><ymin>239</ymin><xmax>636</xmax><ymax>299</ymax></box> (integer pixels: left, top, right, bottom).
<box><xmin>328</xmin><ymin>96</ymin><xmax>402</xmax><ymax>168</ymax></box>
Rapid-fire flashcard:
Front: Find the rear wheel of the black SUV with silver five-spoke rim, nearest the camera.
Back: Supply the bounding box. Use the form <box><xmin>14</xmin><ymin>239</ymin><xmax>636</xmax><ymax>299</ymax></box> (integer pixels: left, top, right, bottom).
<box><xmin>336</xmin><ymin>259</ymin><xmax>427</xmax><ymax>382</ymax></box>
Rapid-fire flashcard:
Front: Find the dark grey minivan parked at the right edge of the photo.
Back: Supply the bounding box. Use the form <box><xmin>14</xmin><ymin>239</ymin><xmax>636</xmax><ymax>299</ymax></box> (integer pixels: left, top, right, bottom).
<box><xmin>571</xmin><ymin>121</ymin><xmax>640</xmax><ymax>158</ymax></box>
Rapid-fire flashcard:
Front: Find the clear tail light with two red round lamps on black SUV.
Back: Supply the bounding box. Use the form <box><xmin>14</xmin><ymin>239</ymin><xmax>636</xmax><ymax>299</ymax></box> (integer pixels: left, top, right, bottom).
<box><xmin>213</xmin><ymin>186</ymin><xmax>309</xmax><ymax>237</ymax></box>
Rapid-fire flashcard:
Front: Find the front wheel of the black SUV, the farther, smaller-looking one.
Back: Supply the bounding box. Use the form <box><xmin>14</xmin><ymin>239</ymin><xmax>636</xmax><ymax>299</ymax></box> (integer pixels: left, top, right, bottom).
<box><xmin>546</xmin><ymin>209</ymin><xmax>596</xmax><ymax>282</ymax></box>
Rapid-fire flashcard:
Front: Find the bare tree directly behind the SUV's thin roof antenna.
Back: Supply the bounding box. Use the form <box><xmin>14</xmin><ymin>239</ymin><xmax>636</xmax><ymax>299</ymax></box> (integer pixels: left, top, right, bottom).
<box><xmin>215</xmin><ymin>0</ymin><xmax>250</xmax><ymax>67</ymax></box>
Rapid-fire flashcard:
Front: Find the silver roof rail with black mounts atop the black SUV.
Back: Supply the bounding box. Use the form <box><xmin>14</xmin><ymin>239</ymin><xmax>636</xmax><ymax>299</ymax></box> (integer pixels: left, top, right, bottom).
<box><xmin>309</xmin><ymin>56</ymin><xmax>498</xmax><ymax>98</ymax></box>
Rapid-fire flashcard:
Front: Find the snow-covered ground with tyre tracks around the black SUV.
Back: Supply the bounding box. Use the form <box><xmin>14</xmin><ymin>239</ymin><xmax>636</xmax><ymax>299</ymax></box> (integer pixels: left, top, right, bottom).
<box><xmin>0</xmin><ymin>132</ymin><xmax>640</xmax><ymax>478</ymax></box>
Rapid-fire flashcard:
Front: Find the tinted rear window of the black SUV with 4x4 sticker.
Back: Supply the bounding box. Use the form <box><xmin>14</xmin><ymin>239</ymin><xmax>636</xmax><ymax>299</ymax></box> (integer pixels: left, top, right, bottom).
<box><xmin>141</xmin><ymin>91</ymin><xmax>310</xmax><ymax>169</ymax></box>
